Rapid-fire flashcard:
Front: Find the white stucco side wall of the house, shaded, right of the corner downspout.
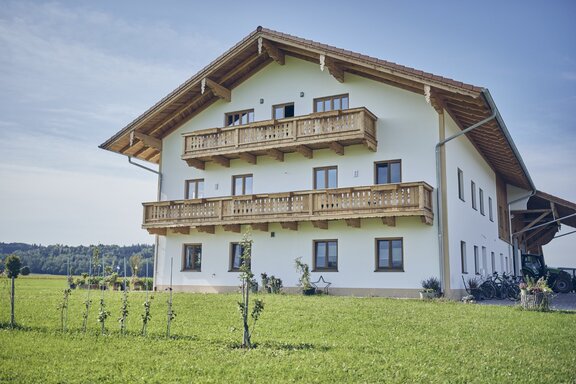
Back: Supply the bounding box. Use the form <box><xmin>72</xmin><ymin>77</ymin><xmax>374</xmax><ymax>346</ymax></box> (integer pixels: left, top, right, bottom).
<box><xmin>445</xmin><ymin>114</ymin><xmax>511</xmax><ymax>289</ymax></box>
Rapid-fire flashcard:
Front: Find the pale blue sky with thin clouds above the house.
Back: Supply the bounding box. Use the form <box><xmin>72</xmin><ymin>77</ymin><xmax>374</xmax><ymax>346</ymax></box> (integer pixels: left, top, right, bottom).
<box><xmin>0</xmin><ymin>0</ymin><xmax>576</xmax><ymax>264</ymax></box>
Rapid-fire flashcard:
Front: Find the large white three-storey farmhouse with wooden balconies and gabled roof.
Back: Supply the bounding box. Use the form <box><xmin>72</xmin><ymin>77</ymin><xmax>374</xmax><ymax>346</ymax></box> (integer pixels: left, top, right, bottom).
<box><xmin>101</xmin><ymin>27</ymin><xmax>572</xmax><ymax>297</ymax></box>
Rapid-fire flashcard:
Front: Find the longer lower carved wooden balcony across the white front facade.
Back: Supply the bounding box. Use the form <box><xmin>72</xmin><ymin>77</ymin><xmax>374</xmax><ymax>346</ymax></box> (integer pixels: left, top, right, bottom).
<box><xmin>142</xmin><ymin>182</ymin><xmax>434</xmax><ymax>235</ymax></box>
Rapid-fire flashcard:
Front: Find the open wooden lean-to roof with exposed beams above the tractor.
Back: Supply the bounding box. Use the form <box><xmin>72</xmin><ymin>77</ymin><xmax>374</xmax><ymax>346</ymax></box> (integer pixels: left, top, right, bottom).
<box><xmin>512</xmin><ymin>191</ymin><xmax>576</xmax><ymax>253</ymax></box>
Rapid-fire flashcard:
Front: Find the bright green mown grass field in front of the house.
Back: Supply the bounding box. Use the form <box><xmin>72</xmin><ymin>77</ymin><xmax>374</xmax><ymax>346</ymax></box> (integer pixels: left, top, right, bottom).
<box><xmin>0</xmin><ymin>276</ymin><xmax>576</xmax><ymax>384</ymax></box>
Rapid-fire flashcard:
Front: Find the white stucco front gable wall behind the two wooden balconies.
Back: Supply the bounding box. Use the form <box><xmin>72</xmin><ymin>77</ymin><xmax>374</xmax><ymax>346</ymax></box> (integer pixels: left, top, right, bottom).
<box><xmin>156</xmin><ymin>57</ymin><xmax>439</xmax><ymax>289</ymax></box>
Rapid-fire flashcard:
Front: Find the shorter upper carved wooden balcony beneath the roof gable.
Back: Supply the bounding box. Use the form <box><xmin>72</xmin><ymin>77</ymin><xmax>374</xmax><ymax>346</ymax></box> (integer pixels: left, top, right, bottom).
<box><xmin>182</xmin><ymin>108</ymin><xmax>377</xmax><ymax>169</ymax></box>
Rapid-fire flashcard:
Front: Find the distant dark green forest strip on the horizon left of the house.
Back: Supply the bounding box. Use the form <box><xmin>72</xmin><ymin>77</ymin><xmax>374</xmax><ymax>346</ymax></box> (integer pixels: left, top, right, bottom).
<box><xmin>0</xmin><ymin>243</ymin><xmax>154</xmax><ymax>277</ymax></box>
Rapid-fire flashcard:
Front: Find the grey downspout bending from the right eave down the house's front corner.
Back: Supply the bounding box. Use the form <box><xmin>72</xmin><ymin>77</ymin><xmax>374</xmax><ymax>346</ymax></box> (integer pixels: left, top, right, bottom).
<box><xmin>435</xmin><ymin>90</ymin><xmax>498</xmax><ymax>290</ymax></box>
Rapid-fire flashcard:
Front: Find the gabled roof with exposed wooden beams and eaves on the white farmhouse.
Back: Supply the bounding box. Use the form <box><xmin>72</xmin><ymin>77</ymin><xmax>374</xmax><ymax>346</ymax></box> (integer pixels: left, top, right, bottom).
<box><xmin>100</xmin><ymin>27</ymin><xmax>533</xmax><ymax>189</ymax></box>
